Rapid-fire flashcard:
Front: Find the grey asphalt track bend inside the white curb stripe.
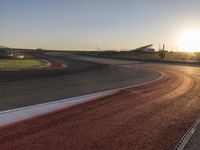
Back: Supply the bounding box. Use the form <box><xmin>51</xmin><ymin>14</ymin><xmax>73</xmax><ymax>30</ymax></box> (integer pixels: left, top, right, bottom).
<box><xmin>0</xmin><ymin>56</ymin><xmax>159</xmax><ymax>111</ymax></box>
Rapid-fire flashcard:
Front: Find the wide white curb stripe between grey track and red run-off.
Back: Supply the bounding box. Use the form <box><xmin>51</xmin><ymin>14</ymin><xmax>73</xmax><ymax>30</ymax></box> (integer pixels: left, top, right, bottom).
<box><xmin>0</xmin><ymin>91</ymin><xmax>117</xmax><ymax>127</ymax></box>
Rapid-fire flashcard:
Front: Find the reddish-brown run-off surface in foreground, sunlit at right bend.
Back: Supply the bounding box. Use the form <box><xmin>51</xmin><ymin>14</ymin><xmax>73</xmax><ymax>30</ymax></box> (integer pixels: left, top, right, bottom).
<box><xmin>0</xmin><ymin>56</ymin><xmax>200</xmax><ymax>150</ymax></box>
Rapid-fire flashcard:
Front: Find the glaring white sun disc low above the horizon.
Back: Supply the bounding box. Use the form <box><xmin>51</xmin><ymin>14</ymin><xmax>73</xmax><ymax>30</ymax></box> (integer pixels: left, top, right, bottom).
<box><xmin>179</xmin><ymin>30</ymin><xmax>200</xmax><ymax>52</ymax></box>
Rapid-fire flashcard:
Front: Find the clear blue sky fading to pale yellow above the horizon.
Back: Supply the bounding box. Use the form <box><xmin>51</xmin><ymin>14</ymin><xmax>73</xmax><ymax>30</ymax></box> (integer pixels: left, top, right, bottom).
<box><xmin>0</xmin><ymin>0</ymin><xmax>200</xmax><ymax>51</ymax></box>
